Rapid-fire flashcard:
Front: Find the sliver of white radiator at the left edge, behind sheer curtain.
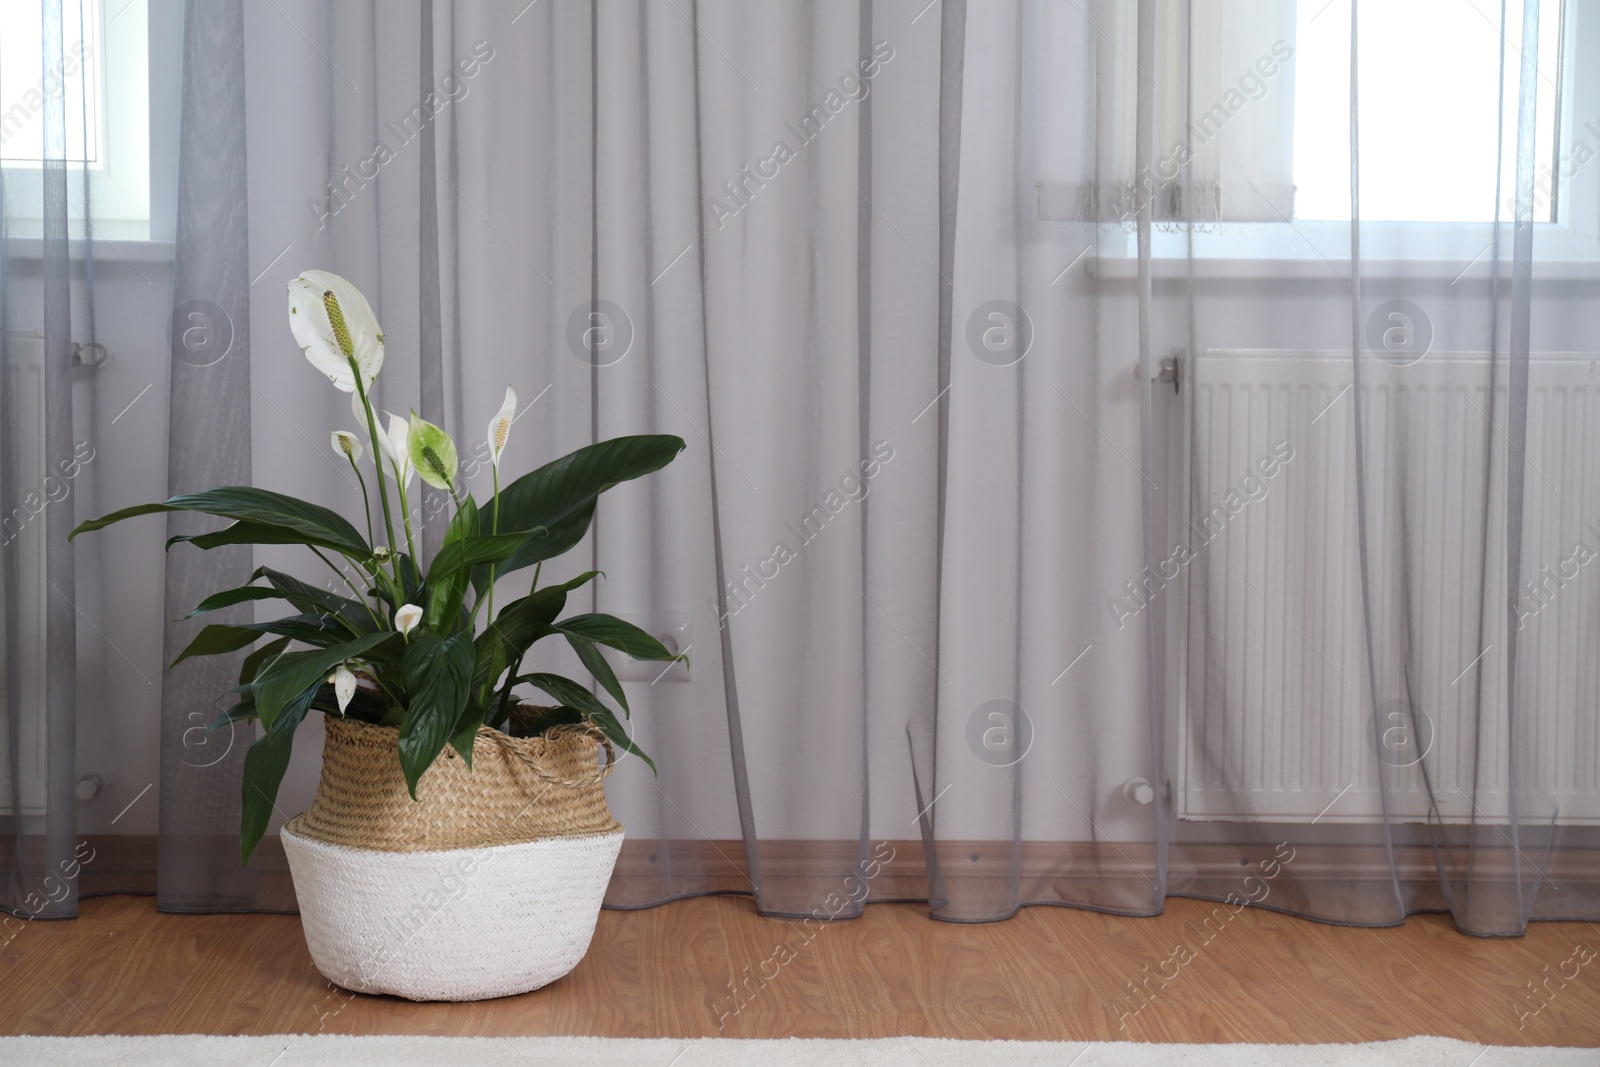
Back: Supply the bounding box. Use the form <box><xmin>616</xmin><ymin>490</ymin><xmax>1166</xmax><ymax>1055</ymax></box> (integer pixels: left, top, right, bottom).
<box><xmin>0</xmin><ymin>333</ymin><xmax>50</xmax><ymax>816</ymax></box>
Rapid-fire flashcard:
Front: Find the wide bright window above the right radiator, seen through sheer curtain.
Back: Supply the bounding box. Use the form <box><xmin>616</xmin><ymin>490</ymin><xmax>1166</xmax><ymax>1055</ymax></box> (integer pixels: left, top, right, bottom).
<box><xmin>1034</xmin><ymin>0</ymin><xmax>1600</xmax><ymax>267</ymax></box>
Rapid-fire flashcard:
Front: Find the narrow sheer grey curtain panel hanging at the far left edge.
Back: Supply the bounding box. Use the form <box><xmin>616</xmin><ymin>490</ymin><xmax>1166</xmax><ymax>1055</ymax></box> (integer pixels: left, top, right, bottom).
<box><xmin>0</xmin><ymin>0</ymin><xmax>93</xmax><ymax>927</ymax></box>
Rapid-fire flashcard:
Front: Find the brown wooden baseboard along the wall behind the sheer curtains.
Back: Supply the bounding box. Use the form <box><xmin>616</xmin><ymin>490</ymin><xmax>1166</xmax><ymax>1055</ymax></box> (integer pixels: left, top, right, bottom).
<box><xmin>15</xmin><ymin>833</ymin><xmax>1600</xmax><ymax>912</ymax></box>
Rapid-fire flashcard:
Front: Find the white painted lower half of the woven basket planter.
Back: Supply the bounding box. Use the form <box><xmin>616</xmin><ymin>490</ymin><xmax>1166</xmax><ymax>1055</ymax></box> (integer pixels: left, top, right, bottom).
<box><xmin>283</xmin><ymin>827</ymin><xmax>622</xmax><ymax>1000</ymax></box>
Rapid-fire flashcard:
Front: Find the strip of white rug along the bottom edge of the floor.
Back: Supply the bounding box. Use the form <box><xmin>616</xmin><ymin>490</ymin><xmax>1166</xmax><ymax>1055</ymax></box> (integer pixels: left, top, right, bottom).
<box><xmin>0</xmin><ymin>1035</ymin><xmax>1600</xmax><ymax>1067</ymax></box>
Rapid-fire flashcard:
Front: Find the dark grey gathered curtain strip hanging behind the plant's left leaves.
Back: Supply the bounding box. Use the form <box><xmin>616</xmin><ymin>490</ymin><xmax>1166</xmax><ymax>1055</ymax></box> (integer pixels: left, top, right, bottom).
<box><xmin>157</xmin><ymin>0</ymin><xmax>259</xmax><ymax>912</ymax></box>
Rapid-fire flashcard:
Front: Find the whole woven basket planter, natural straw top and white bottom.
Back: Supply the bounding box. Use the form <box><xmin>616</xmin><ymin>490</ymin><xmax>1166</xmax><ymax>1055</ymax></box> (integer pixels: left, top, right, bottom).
<box><xmin>283</xmin><ymin>715</ymin><xmax>622</xmax><ymax>1000</ymax></box>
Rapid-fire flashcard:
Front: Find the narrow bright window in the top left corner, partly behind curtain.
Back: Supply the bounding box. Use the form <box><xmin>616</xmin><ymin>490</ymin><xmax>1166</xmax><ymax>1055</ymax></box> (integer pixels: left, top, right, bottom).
<box><xmin>0</xmin><ymin>0</ymin><xmax>150</xmax><ymax>240</ymax></box>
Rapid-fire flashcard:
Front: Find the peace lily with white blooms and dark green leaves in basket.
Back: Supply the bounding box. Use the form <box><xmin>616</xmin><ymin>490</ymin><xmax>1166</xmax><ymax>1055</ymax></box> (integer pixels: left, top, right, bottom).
<box><xmin>72</xmin><ymin>270</ymin><xmax>683</xmax><ymax>862</ymax></box>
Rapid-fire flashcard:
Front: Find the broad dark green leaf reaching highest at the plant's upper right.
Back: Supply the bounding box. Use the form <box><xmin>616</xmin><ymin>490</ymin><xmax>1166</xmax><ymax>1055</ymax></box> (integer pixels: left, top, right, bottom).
<box><xmin>499</xmin><ymin>434</ymin><xmax>683</xmax><ymax>574</ymax></box>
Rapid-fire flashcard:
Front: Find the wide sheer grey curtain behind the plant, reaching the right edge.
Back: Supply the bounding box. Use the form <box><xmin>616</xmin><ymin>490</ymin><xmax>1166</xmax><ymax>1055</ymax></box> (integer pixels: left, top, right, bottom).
<box><xmin>93</xmin><ymin>0</ymin><xmax>1600</xmax><ymax>940</ymax></box>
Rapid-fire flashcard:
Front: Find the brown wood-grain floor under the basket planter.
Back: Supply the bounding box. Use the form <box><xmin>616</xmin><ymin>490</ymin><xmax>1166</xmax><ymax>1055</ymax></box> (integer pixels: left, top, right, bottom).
<box><xmin>0</xmin><ymin>896</ymin><xmax>1600</xmax><ymax>1046</ymax></box>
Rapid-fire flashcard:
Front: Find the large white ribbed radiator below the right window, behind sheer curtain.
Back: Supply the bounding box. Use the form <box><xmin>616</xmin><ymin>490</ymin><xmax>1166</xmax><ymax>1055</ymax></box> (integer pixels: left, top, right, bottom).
<box><xmin>1168</xmin><ymin>352</ymin><xmax>1600</xmax><ymax>824</ymax></box>
